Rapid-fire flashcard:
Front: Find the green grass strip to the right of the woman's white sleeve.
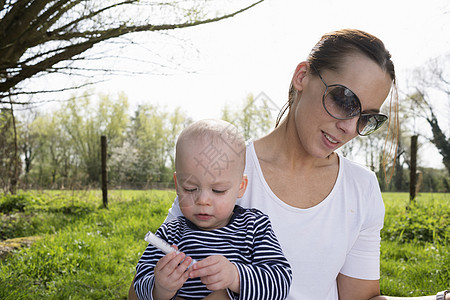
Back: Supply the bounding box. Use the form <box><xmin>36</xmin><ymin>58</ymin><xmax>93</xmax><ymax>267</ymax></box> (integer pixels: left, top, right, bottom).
<box><xmin>380</xmin><ymin>193</ymin><xmax>450</xmax><ymax>297</ymax></box>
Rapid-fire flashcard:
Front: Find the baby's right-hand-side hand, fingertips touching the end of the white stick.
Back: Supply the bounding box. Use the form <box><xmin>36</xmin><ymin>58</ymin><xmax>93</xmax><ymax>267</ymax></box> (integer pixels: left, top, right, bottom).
<box><xmin>189</xmin><ymin>255</ymin><xmax>240</xmax><ymax>293</ymax></box>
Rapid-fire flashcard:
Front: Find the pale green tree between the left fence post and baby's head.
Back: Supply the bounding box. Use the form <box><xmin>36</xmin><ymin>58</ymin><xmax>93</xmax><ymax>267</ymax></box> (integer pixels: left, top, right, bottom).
<box><xmin>109</xmin><ymin>105</ymin><xmax>192</xmax><ymax>188</ymax></box>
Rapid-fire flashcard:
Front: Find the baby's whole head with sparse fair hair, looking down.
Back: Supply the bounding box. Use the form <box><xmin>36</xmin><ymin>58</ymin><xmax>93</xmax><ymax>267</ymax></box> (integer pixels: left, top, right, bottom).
<box><xmin>174</xmin><ymin>119</ymin><xmax>247</xmax><ymax>230</ymax></box>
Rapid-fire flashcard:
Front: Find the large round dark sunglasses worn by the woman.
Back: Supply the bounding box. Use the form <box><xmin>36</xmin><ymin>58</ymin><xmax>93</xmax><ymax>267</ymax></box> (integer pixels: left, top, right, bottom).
<box><xmin>311</xmin><ymin>64</ymin><xmax>388</xmax><ymax>136</ymax></box>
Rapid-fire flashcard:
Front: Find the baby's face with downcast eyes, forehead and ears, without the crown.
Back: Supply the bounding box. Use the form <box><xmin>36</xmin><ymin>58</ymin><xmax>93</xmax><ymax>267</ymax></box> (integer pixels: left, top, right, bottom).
<box><xmin>174</xmin><ymin>141</ymin><xmax>247</xmax><ymax>230</ymax></box>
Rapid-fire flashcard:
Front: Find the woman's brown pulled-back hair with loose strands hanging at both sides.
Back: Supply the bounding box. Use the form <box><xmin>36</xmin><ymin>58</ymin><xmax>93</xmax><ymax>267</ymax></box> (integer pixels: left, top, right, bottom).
<box><xmin>275</xmin><ymin>29</ymin><xmax>399</xmax><ymax>178</ymax></box>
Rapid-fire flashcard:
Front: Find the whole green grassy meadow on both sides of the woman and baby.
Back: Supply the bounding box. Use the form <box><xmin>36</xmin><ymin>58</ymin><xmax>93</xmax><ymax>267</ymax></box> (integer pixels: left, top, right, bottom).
<box><xmin>0</xmin><ymin>190</ymin><xmax>450</xmax><ymax>299</ymax></box>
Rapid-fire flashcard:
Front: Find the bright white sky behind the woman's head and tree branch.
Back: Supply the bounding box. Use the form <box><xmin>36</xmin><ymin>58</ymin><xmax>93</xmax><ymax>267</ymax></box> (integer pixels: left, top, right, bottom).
<box><xmin>42</xmin><ymin>0</ymin><xmax>450</xmax><ymax>167</ymax></box>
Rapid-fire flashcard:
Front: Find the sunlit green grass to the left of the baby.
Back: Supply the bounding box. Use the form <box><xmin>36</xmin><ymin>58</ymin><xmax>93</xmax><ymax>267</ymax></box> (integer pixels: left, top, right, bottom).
<box><xmin>0</xmin><ymin>191</ymin><xmax>175</xmax><ymax>299</ymax></box>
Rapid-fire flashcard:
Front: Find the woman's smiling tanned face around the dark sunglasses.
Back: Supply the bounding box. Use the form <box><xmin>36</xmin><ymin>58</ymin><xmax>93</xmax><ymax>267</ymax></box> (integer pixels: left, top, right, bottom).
<box><xmin>293</xmin><ymin>54</ymin><xmax>392</xmax><ymax>157</ymax></box>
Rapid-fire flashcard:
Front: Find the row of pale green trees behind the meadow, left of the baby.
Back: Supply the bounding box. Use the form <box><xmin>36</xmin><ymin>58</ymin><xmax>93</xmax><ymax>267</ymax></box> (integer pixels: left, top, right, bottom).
<box><xmin>0</xmin><ymin>94</ymin><xmax>192</xmax><ymax>189</ymax></box>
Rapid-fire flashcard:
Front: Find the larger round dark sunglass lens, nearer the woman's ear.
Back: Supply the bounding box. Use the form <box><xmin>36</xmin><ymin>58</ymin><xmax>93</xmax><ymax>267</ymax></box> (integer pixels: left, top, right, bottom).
<box><xmin>324</xmin><ymin>86</ymin><xmax>361</xmax><ymax>119</ymax></box>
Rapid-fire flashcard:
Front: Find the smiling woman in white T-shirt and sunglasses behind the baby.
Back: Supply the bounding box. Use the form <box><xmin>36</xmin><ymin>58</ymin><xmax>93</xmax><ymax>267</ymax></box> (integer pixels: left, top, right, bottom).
<box><xmin>129</xmin><ymin>30</ymin><xmax>450</xmax><ymax>300</ymax></box>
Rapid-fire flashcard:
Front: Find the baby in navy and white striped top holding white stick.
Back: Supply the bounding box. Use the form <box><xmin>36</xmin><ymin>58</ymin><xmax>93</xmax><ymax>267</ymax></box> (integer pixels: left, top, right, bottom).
<box><xmin>134</xmin><ymin>120</ymin><xmax>292</xmax><ymax>300</ymax></box>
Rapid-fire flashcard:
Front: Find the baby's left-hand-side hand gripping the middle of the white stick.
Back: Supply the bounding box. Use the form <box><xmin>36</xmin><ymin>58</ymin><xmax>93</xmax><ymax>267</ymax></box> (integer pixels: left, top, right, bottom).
<box><xmin>153</xmin><ymin>246</ymin><xmax>192</xmax><ymax>299</ymax></box>
